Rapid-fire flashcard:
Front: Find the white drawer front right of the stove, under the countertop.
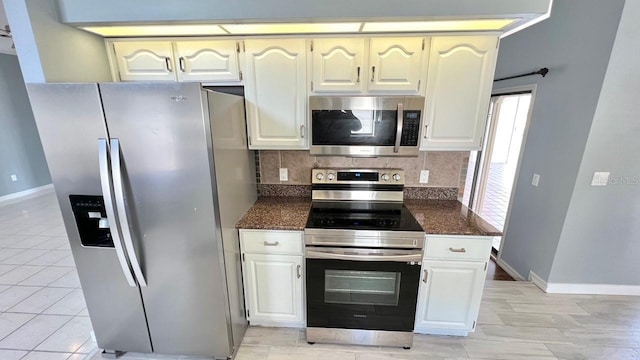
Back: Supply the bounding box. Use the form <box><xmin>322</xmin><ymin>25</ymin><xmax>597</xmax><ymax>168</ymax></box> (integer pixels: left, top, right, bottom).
<box><xmin>424</xmin><ymin>236</ymin><xmax>492</xmax><ymax>261</ymax></box>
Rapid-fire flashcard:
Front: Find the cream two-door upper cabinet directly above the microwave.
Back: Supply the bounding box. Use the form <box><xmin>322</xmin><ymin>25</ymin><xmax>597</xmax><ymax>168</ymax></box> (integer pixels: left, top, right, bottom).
<box><xmin>310</xmin><ymin>37</ymin><xmax>428</xmax><ymax>95</ymax></box>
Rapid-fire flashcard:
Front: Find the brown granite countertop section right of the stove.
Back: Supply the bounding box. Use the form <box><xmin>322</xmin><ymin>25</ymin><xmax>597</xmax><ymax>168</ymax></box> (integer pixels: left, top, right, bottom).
<box><xmin>404</xmin><ymin>200</ymin><xmax>502</xmax><ymax>236</ymax></box>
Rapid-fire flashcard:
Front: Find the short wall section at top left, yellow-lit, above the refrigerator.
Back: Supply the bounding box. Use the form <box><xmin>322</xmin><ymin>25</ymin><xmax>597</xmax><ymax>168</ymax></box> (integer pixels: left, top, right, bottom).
<box><xmin>4</xmin><ymin>0</ymin><xmax>111</xmax><ymax>83</ymax></box>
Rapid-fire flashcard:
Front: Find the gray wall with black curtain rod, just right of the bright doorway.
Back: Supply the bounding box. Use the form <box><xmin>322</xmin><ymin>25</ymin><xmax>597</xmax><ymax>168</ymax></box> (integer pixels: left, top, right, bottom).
<box><xmin>494</xmin><ymin>0</ymin><xmax>624</xmax><ymax>280</ymax></box>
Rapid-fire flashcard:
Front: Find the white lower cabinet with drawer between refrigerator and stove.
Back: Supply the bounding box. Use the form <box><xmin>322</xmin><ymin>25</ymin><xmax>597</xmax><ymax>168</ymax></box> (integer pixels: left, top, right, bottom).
<box><xmin>240</xmin><ymin>230</ymin><xmax>305</xmax><ymax>327</ymax></box>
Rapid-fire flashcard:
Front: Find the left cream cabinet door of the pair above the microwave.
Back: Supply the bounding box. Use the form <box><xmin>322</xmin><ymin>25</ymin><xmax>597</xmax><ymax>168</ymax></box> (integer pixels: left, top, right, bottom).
<box><xmin>311</xmin><ymin>39</ymin><xmax>367</xmax><ymax>93</ymax></box>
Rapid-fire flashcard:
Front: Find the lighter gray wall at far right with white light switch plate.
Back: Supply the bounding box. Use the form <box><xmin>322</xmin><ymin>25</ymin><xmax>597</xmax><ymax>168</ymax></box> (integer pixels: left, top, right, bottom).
<box><xmin>549</xmin><ymin>1</ymin><xmax>640</xmax><ymax>286</ymax></box>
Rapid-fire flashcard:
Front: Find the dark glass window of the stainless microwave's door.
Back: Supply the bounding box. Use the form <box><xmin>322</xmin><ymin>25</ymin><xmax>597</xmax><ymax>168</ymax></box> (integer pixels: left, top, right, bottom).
<box><xmin>311</xmin><ymin>110</ymin><xmax>397</xmax><ymax>146</ymax></box>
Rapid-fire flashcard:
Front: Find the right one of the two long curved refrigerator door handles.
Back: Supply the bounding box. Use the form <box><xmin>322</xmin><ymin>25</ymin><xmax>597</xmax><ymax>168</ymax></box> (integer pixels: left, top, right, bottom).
<box><xmin>110</xmin><ymin>138</ymin><xmax>147</xmax><ymax>287</ymax></box>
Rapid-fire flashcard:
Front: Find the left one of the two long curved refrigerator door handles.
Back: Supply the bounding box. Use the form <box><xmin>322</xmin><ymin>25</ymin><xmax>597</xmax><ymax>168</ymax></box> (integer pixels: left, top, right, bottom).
<box><xmin>98</xmin><ymin>139</ymin><xmax>136</xmax><ymax>287</ymax></box>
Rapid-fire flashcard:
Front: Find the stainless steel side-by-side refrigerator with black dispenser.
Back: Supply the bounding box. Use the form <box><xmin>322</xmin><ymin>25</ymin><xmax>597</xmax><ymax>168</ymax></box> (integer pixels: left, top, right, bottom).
<box><xmin>27</xmin><ymin>83</ymin><xmax>256</xmax><ymax>358</ymax></box>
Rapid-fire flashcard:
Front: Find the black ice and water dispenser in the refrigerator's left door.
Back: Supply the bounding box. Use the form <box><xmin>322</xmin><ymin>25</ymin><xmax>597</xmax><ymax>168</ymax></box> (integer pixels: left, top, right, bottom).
<box><xmin>69</xmin><ymin>195</ymin><xmax>113</xmax><ymax>247</ymax></box>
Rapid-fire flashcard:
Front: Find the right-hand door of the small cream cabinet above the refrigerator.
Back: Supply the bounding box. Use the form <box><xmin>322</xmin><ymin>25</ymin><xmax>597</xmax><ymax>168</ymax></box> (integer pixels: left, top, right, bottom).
<box><xmin>175</xmin><ymin>40</ymin><xmax>240</xmax><ymax>81</ymax></box>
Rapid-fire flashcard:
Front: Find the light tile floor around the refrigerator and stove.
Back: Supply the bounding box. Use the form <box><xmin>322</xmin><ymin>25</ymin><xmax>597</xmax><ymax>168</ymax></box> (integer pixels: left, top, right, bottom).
<box><xmin>0</xmin><ymin>194</ymin><xmax>640</xmax><ymax>360</ymax></box>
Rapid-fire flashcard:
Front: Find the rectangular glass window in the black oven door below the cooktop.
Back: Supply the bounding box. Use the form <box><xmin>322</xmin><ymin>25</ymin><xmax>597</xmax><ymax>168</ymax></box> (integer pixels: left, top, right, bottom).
<box><xmin>324</xmin><ymin>270</ymin><xmax>400</xmax><ymax>306</ymax></box>
